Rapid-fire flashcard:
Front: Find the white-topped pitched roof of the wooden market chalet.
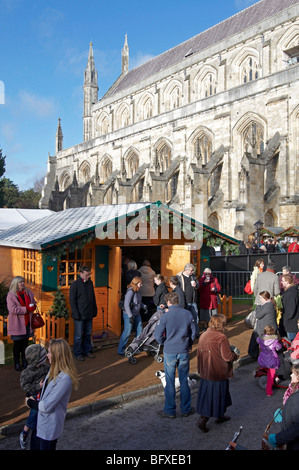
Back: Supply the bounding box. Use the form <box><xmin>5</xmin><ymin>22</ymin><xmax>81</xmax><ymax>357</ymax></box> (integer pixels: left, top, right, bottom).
<box><xmin>0</xmin><ymin>201</ymin><xmax>237</xmax><ymax>250</ymax></box>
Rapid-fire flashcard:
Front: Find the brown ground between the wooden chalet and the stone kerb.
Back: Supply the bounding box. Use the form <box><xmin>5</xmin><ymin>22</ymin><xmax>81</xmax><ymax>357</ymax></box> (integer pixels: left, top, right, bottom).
<box><xmin>0</xmin><ymin>305</ymin><xmax>251</xmax><ymax>428</ymax></box>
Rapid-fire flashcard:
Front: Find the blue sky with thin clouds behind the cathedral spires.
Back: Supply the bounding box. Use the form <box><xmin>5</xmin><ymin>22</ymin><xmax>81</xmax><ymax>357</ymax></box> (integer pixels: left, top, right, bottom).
<box><xmin>0</xmin><ymin>0</ymin><xmax>257</xmax><ymax>190</ymax></box>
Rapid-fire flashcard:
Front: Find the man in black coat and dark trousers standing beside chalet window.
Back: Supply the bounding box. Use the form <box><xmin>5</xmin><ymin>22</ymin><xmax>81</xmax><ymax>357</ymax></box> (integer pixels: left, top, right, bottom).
<box><xmin>69</xmin><ymin>266</ymin><xmax>98</xmax><ymax>361</ymax></box>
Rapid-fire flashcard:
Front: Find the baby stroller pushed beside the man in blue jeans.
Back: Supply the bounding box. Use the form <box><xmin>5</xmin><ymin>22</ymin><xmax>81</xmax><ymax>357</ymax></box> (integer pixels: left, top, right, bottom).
<box><xmin>125</xmin><ymin>309</ymin><xmax>164</xmax><ymax>364</ymax></box>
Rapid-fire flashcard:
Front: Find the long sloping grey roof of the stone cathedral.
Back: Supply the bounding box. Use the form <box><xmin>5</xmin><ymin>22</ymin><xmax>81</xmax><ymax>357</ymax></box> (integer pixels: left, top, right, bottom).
<box><xmin>102</xmin><ymin>0</ymin><xmax>298</xmax><ymax>99</ymax></box>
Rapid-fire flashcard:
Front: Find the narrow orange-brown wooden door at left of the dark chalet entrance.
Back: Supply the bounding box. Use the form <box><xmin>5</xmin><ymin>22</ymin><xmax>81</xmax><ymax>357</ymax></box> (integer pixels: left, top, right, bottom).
<box><xmin>107</xmin><ymin>246</ymin><xmax>121</xmax><ymax>335</ymax></box>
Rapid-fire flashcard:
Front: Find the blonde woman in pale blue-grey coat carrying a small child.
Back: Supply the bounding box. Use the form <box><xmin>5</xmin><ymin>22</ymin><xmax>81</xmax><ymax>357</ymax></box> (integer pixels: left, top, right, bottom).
<box><xmin>26</xmin><ymin>338</ymin><xmax>78</xmax><ymax>450</ymax></box>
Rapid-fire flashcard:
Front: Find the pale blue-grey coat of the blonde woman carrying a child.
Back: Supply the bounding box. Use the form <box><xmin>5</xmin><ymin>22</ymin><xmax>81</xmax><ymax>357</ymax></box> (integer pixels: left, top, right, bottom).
<box><xmin>36</xmin><ymin>372</ymin><xmax>72</xmax><ymax>441</ymax></box>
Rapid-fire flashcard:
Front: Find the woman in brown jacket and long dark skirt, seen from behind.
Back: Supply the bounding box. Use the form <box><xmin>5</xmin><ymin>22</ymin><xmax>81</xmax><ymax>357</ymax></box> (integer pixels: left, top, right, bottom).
<box><xmin>196</xmin><ymin>314</ymin><xmax>238</xmax><ymax>432</ymax></box>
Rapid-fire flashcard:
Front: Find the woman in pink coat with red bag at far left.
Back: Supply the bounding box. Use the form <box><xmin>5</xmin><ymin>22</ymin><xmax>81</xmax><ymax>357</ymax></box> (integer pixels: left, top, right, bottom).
<box><xmin>6</xmin><ymin>276</ymin><xmax>36</xmax><ymax>371</ymax></box>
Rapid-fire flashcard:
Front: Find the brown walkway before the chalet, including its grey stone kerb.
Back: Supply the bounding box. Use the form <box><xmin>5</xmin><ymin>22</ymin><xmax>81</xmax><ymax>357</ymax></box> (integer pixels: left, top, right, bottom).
<box><xmin>0</xmin><ymin>305</ymin><xmax>252</xmax><ymax>436</ymax></box>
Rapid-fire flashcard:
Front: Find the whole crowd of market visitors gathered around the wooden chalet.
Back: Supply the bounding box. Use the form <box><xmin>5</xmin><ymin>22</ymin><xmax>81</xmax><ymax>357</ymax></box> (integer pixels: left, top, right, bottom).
<box><xmin>7</xmin><ymin>252</ymin><xmax>299</xmax><ymax>450</ymax></box>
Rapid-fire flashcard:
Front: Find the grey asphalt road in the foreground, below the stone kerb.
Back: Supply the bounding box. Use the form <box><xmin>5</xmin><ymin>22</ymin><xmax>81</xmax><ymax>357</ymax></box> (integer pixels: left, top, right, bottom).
<box><xmin>0</xmin><ymin>363</ymin><xmax>290</xmax><ymax>456</ymax></box>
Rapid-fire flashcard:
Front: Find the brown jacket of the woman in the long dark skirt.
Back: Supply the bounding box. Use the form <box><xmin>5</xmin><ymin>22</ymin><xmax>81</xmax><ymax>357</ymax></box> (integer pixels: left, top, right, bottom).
<box><xmin>197</xmin><ymin>328</ymin><xmax>238</xmax><ymax>380</ymax></box>
